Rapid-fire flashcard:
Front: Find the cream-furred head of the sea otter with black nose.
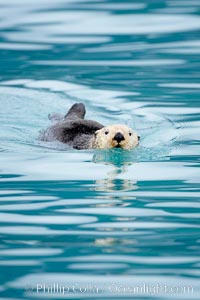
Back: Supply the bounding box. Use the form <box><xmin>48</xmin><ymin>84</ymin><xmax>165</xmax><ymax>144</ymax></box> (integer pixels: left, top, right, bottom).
<box><xmin>95</xmin><ymin>124</ymin><xmax>140</xmax><ymax>150</ymax></box>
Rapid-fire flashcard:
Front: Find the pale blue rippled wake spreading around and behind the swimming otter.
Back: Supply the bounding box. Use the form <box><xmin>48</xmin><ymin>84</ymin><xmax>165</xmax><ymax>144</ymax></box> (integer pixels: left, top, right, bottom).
<box><xmin>0</xmin><ymin>80</ymin><xmax>178</xmax><ymax>163</ymax></box>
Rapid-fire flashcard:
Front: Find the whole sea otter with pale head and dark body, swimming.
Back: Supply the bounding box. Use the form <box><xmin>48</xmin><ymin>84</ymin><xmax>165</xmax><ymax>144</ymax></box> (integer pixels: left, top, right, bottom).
<box><xmin>40</xmin><ymin>103</ymin><xmax>140</xmax><ymax>150</ymax></box>
